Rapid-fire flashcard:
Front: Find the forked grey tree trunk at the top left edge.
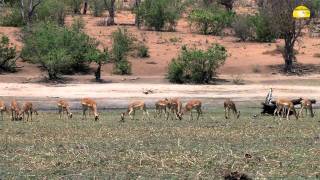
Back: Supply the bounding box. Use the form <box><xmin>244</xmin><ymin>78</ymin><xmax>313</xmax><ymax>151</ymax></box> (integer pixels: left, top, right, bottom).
<box><xmin>19</xmin><ymin>0</ymin><xmax>43</xmax><ymax>27</ymax></box>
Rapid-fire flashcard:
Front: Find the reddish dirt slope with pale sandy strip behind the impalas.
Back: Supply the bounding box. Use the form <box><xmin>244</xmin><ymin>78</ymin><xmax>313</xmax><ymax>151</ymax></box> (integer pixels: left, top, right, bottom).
<box><xmin>0</xmin><ymin>11</ymin><xmax>320</xmax><ymax>107</ymax></box>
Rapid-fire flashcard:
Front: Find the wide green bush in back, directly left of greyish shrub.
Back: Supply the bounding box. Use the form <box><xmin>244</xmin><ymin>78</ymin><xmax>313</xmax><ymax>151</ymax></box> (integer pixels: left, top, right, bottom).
<box><xmin>188</xmin><ymin>8</ymin><xmax>235</xmax><ymax>35</ymax></box>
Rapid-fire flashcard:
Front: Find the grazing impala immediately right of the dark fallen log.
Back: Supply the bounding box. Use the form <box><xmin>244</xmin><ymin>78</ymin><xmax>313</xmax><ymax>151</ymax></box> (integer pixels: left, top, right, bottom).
<box><xmin>273</xmin><ymin>98</ymin><xmax>298</xmax><ymax>120</ymax></box>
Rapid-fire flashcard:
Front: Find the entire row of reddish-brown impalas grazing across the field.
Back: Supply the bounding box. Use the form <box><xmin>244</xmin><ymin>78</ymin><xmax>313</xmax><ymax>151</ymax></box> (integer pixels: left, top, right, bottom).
<box><xmin>0</xmin><ymin>98</ymin><xmax>314</xmax><ymax>122</ymax></box>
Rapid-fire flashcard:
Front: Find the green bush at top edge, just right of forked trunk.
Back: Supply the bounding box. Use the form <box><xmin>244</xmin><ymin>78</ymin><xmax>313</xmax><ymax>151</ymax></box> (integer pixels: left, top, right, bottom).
<box><xmin>36</xmin><ymin>0</ymin><xmax>66</xmax><ymax>25</ymax></box>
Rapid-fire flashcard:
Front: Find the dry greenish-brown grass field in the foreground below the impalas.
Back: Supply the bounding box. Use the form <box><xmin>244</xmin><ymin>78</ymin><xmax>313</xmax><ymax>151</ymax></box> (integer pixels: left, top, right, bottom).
<box><xmin>0</xmin><ymin>107</ymin><xmax>320</xmax><ymax>179</ymax></box>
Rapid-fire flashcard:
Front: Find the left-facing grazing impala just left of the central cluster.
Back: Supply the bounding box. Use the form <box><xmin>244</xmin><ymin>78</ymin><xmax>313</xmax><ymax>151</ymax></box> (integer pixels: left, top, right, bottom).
<box><xmin>121</xmin><ymin>101</ymin><xmax>150</xmax><ymax>121</ymax></box>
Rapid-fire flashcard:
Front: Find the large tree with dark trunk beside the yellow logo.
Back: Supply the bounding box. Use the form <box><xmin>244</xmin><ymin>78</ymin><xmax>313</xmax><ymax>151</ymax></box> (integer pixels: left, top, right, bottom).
<box><xmin>259</xmin><ymin>0</ymin><xmax>305</xmax><ymax>73</ymax></box>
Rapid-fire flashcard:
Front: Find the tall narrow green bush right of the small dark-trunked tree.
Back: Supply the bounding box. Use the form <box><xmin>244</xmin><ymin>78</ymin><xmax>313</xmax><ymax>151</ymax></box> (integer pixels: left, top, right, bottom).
<box><xmin>112</xmin><ymin>28</ymin><xmax>133</xmax><ymax>75</ymax></box>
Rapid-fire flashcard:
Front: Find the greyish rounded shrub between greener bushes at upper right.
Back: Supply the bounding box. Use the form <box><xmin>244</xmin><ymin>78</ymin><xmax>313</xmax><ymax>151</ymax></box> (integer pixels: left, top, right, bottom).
<box><xmin>232</xmin><ymin>16</ymin><xmax>254</xmax><ymax>41</ymax></box>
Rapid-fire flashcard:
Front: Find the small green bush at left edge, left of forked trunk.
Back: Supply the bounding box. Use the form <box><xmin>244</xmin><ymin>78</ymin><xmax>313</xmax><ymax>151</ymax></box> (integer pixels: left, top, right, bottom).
<box><xmin>0</xmin><ymin>8</ymin><xmax>25</xmax><ymax>27</ymax></box>
